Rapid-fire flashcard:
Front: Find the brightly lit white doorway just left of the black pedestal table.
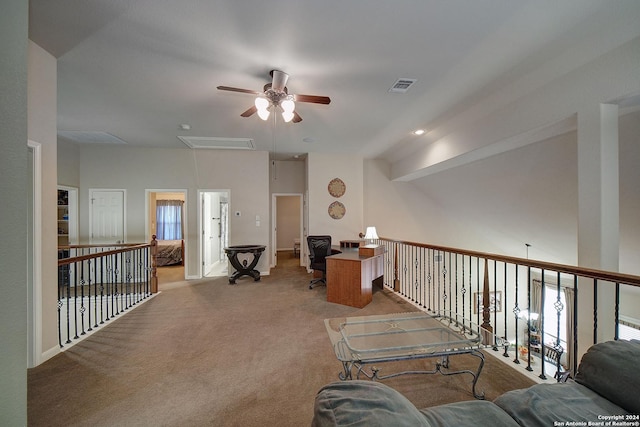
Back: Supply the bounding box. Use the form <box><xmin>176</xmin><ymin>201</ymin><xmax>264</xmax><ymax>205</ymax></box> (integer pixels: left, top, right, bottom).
<box><xmin>198</xmin><ymin>190</ymin><xmax>230</xmax><ymax>277</ymax></box>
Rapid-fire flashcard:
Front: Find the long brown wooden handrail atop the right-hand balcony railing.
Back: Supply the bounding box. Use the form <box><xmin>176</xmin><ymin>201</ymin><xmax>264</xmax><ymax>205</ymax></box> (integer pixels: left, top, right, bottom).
<box><xmin>379</xmin><ymin>237</ymin><xmax>640</xmax><ymax>287</ymax></box>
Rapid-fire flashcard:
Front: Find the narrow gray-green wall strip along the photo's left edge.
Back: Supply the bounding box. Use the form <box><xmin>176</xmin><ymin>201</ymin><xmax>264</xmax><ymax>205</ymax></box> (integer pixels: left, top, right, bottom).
<box><xmin>0</xmin><ymin>0</ymin><xmax>29</xmax><ymax>426</ymax></box>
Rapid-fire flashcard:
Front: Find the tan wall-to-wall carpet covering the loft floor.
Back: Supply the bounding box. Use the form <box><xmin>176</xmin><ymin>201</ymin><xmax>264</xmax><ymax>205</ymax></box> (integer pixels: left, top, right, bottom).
<box><xmin>28</xmin><ymin>254</ymin><xmax>532</xmax><ymax>427</ymax></box>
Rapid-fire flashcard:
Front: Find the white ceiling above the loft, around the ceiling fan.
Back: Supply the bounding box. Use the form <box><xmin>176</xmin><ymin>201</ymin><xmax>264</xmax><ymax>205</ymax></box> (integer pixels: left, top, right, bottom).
<box><xmin>29</xmin><ymin>0</ymin><xmax>640</xmax><ymax>159</ymax></box>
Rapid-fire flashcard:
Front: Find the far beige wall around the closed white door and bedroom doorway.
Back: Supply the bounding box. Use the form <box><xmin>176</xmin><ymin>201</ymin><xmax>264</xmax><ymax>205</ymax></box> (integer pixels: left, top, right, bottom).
<box><xmin>79</xmin><ymin>145</ymin><xmax>270</xmax><ymax>277</ymax></box>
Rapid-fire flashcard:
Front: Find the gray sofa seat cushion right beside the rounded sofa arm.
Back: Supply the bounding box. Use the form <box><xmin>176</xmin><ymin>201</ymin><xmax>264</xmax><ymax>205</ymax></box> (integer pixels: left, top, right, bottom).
<box><xmin>420</xmin><ymin>400</ymin><xmax>519</xmax><ymax>427</ymax></box>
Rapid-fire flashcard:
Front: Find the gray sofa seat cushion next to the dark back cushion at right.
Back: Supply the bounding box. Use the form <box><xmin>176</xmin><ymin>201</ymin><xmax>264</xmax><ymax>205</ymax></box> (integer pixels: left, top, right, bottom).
<box><xmin>494</xmin><ymin>380</ymin><xmax>627</xmax><ymax>427</ymax></box>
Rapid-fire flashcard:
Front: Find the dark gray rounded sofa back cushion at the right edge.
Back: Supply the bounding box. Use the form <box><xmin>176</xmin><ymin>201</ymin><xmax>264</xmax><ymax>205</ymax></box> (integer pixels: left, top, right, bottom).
<box><xmin>576</xmin><ymin>340</ymin><xmax>640</xmax><ymax>414</ymax></box>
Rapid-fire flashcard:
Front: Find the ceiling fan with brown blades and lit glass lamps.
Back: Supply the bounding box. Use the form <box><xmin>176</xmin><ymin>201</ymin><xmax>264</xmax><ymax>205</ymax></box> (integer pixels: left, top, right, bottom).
<box><xmin>218</xmin><ymin>70</ymin><xmax>331</xmax><ymax>123</ymax></box>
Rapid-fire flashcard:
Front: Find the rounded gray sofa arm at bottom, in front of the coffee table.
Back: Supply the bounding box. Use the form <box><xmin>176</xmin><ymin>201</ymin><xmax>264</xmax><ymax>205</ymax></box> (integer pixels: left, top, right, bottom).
<box><xmin>311</xmin><ymin>380</ymin><xmax>429</xmax><ymax>427</ymax></box>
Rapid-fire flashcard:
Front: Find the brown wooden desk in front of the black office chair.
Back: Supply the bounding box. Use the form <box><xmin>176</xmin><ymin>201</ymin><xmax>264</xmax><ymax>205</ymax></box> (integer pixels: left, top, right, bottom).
<box><xmin>326</xmin><ymin>251</ymin><xmax>384</xmax><ymax>308</ymax></box>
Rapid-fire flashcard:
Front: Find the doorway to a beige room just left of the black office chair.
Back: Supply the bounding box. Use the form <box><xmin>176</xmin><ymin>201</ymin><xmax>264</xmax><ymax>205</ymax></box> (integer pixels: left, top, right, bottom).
<box><xmin>271</xmin><ymin>193</ymin><xmax>305</xmax><ymax>267</ymax></box>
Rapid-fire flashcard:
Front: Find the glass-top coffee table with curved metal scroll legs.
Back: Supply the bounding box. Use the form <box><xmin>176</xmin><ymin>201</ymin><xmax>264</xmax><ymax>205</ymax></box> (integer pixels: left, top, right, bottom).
<box><xmin>324</xmin><ymin>312</ymin><xmax>484</xmax><ymax>399</ymax></box>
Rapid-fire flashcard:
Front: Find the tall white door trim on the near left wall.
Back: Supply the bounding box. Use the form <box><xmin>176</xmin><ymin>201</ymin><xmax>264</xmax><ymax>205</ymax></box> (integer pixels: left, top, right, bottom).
<box><xmin>27</xmin><ymin>140</ymin><xmax>43</xmax><ymax>367</ymax></box>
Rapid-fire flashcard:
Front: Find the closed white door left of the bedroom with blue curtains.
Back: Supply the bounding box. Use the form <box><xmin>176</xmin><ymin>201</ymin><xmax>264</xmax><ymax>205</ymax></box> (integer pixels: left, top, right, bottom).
<box><xmin>89</xmin><ymin>190</ymin><xmax>125</xmax><ymax>244</ymax></box>
